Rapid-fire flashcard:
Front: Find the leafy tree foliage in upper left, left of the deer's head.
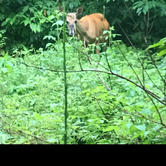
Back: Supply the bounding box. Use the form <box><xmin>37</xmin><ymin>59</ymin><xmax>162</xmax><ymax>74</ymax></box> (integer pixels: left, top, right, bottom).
<box><xmin>0</xmin><ymin>0</ymin><xmax>60</xmax><ymax>48</ymax></box>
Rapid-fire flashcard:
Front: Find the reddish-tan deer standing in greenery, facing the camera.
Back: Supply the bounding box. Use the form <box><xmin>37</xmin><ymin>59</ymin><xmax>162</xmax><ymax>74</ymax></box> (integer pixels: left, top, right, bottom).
<box><xmin>59</xmin><ymin>7</ymin><xmax>109</xmax><ymax>54</ymax></box>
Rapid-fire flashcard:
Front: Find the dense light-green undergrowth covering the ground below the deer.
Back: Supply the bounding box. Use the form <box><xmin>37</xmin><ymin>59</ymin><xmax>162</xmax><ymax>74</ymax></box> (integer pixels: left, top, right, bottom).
<box><xmin>0</xmin><ymin>38</ymin><xmax>166</xmax><ymax>144</ymax></box>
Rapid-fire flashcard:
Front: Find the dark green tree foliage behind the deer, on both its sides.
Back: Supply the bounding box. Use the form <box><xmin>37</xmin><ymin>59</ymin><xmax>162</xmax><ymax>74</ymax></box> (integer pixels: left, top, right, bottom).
<box><xmin>0</xmin><ymin>0</ymin><xmax>166</xmax><ymax>50</ymax></box>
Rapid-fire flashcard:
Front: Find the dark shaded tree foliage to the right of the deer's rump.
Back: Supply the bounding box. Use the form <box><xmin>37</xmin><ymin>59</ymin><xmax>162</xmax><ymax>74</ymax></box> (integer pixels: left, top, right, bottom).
<box><xmin>106</xmin><ymin>0</ymin><xmax>166</xmax><ymax>48</ymax></box>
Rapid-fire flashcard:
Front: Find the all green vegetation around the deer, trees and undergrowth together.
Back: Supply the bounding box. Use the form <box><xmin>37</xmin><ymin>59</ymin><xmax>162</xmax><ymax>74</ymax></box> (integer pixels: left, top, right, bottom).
<box><xmin>0</xmin><ymin>0</ymin><xmax>166</xmax><ymax>144</ymax></box>
